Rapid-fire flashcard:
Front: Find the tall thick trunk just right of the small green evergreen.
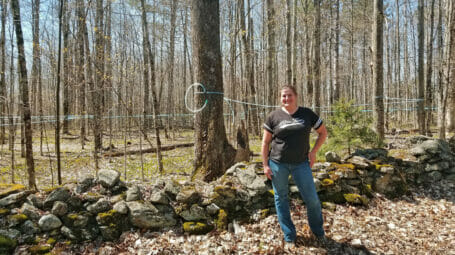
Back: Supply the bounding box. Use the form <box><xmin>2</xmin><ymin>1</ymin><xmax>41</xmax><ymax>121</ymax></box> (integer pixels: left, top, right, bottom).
<box><xmin>371</xmin><ymin>0</ymin><xmax>384</xmax><ymax>140</ymax></box>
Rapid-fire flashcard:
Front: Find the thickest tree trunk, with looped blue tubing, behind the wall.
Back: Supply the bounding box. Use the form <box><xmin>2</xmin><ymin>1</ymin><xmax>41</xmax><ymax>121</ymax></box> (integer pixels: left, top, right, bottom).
<box><xmin>191</xmin><ymin>0</ymin><xmax>235</xmax><ymax>181</ymax></box>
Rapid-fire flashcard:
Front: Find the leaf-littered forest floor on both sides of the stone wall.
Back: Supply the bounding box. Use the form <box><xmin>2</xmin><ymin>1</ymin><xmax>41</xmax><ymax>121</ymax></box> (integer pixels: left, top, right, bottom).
<box><xmin>0</xmin><ymin>132</ymin><xmax>455</xmax><ymax>254</ymax></box>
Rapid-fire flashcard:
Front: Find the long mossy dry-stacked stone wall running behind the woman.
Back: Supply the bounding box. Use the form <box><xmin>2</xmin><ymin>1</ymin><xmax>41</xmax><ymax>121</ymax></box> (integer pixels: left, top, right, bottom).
<box><xmin>0</xmin><ymin>135</ymin><xmax>455</xmax><ymax>254</ymax></box>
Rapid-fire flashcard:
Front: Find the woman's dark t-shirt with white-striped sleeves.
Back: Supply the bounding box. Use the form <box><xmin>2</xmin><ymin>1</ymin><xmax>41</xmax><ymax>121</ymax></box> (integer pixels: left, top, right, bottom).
<box><xmin>264</xmin><ymin>107</ymin><xmax>322</xmax><ymax>163</ymax></box>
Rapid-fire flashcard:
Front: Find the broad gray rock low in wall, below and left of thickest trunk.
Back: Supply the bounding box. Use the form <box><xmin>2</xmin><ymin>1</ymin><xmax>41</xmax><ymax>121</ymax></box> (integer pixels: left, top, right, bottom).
<box><xmin>126</xmin><ymin>201</ymin><xmax>177</xmax><ymax>229</ymax></box>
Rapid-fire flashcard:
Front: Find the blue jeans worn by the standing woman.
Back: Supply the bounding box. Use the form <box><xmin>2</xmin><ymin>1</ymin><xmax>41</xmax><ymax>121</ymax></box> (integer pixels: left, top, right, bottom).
<box><xmin>269</xmin><ymin>160</ymin><xmax>324</xmax><ymax>242</ymax></box>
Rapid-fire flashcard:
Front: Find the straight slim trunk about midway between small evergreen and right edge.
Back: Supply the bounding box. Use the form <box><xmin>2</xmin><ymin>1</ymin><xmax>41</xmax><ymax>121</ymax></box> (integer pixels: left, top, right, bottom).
<box><xmin>417</xmin><ymin>0</ymin><xmax>425</xmax><ymax>135</ymax></box>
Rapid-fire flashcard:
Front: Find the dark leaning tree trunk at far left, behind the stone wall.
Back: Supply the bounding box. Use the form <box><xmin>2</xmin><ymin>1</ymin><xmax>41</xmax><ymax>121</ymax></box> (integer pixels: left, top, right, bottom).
<box><xmin>11</xmin><ymin>0</ymin><xmax>37</xmax><ymax>190</ymax></box>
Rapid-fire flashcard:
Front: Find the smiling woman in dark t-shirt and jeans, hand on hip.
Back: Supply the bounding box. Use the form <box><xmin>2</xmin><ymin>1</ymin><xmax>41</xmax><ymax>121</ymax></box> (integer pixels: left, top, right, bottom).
<box><xmin>262</xmin><ymin>85</ymin><xmax>327</xmax><ymax>243</ymax></box>
